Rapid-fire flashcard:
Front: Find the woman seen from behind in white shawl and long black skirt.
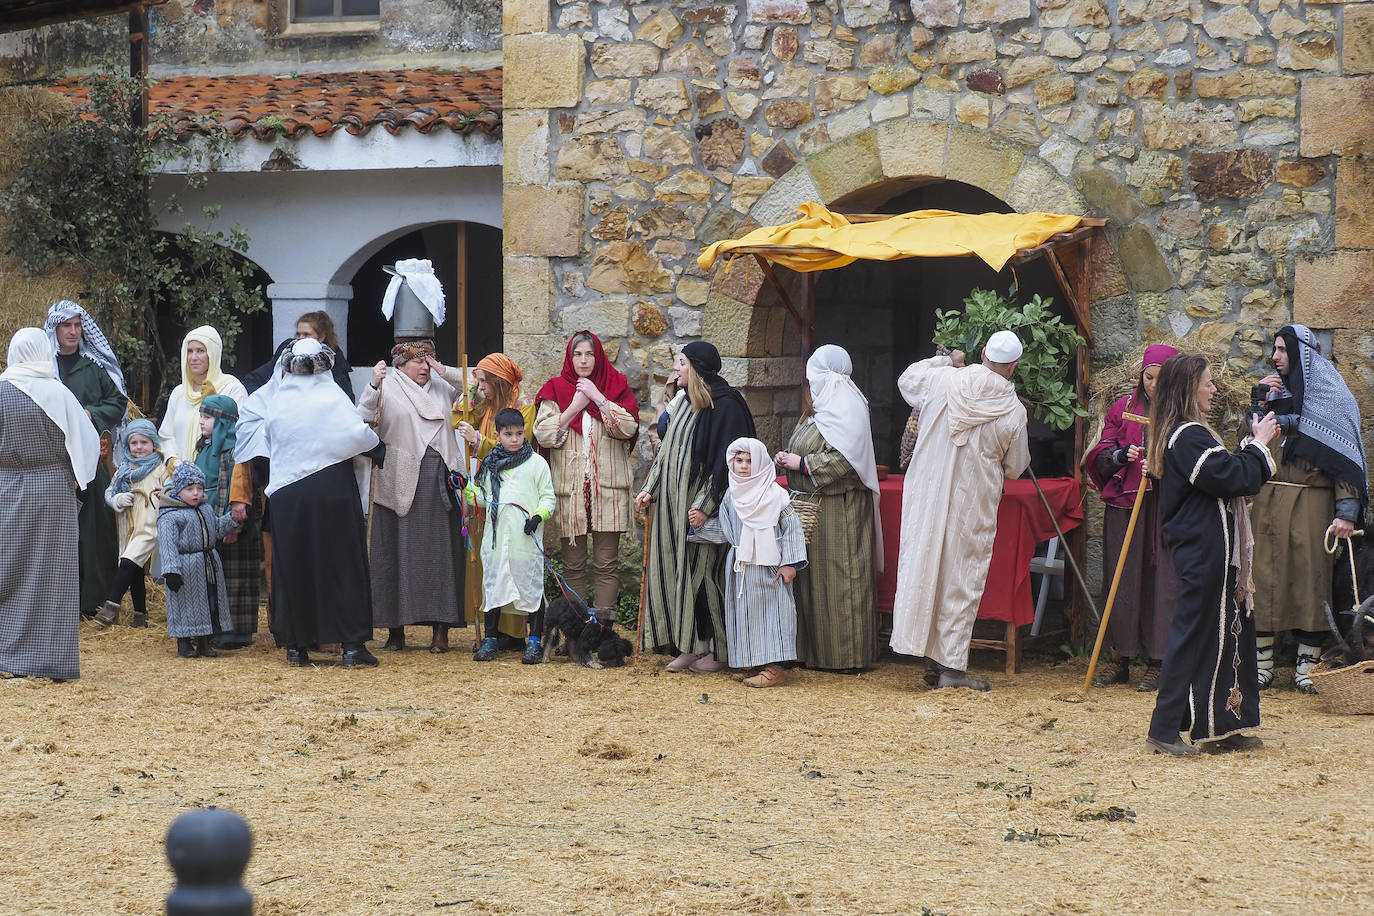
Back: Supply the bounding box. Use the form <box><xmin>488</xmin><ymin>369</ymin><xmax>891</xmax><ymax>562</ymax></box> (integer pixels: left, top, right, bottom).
<box><xmin>234</xmin><ymin>338</ymin><xmax>382</xmax><ymax>667</ymax></box>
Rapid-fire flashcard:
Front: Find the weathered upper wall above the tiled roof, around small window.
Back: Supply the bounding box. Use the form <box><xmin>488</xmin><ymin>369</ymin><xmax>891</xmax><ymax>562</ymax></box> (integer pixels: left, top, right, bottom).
<box><xmin>0</xmin><ymin>0</ymin><xmax>500</xmax><ymax>82</ymax></box>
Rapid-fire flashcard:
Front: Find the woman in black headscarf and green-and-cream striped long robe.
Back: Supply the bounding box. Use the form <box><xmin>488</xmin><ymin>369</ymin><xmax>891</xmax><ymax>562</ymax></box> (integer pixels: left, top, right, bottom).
<box><xmin>636</xmin><ymin>341</ymin><xmax>754</xmax><ymax>672</ymax></box>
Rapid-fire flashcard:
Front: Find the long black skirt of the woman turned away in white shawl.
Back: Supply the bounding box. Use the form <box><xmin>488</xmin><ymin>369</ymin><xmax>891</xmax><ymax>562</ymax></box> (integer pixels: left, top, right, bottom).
<box><xmin>268</xmin><ymin>460</ymin><xmax>372</xmax><ymax>648</ymax></box>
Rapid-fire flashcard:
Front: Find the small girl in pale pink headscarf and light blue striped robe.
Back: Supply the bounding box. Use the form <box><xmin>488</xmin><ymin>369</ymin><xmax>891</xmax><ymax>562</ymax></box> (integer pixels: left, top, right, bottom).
<box><xmin>688</xmin><ymin>437</ymin><xmax>807</xmax><ymax>687</ymax></box>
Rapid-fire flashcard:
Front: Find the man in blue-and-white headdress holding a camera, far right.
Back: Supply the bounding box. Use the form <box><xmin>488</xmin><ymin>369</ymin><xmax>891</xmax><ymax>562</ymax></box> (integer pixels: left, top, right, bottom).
<box><xmin>1250</xmin><ymin>324</ymin><xmax>1369</xmax><ymax>694</ymax></box>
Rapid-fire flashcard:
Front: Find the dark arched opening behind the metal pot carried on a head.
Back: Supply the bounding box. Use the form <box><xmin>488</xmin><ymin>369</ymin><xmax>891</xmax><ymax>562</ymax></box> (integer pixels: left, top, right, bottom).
<box><xmin>348</xmin><ymin>222</ymin><xmax>503</xmax><ymax>368</ymax></box>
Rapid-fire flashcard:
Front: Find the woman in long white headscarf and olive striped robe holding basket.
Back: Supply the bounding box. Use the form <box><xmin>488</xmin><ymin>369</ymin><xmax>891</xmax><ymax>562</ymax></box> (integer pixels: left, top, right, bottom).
<box><xmin>774</xmin><ymin>343</ymin><xmax>882</xmax><ymax>674</ymax></box>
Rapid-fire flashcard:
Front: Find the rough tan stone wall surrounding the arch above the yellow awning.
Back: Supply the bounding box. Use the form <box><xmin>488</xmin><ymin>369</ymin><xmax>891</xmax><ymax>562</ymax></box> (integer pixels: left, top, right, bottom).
<box><xmin>504</xmin><ymin>0</ymin><xmax>1374</xmax><ymax>472</ymax></box>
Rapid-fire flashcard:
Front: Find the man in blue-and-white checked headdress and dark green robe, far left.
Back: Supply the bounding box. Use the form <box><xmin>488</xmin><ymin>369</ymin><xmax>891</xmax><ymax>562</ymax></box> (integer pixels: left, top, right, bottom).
<box><xmin>43</xmin><ymin>299</ymin><xmax>129</xmax><ymax>617</ymax></box>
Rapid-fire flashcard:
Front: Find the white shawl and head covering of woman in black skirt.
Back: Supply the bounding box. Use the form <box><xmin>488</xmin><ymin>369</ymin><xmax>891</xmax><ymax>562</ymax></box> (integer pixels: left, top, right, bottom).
<box><xmin>234</xmin><ymin>338</ymin><xmax>379</xmax><ymax>496</ymax></box>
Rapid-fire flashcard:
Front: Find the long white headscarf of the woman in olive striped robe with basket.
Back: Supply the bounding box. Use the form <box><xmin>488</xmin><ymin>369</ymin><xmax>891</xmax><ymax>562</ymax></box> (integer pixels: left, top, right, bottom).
<box><xmin>807</xmin><ymin>343</ymin><xmax>882</xmax><ymax>573</ymax></box>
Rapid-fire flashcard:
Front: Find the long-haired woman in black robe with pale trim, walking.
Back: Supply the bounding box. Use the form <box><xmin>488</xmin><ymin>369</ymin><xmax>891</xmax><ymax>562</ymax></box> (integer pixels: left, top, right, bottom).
<box><xmin>1146</xmin><ymin>354</ymin><xmax>1279</xmax><ymax>757</ymax></box>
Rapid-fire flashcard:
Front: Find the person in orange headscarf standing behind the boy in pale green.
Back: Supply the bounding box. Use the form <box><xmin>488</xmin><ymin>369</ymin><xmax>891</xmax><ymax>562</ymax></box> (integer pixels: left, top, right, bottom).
<box><xmin>453</xmin><ymin>353</ymin><xmax>536</xmax><ymax>650</ymax></box>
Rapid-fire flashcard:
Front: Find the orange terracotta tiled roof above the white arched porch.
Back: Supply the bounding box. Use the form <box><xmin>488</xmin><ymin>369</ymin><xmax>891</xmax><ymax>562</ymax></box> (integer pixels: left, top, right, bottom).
<box><xmin>54</xmin><ymin>67</ymin><xmax>502</xmax><ymax>140</ymax></box>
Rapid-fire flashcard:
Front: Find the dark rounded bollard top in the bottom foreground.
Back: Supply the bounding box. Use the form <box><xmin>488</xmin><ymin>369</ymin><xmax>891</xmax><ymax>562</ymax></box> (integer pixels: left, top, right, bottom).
<box><xmin>168</xmin><ymin>808</ymin><xmax>253</xmax><ymax>916</ymax></box>
